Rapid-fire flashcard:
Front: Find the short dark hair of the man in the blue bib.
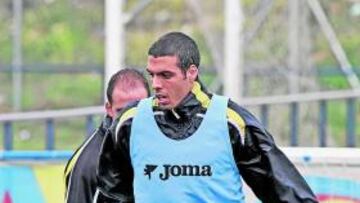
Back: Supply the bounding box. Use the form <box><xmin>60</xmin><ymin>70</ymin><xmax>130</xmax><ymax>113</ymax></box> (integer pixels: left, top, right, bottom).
<box><xmin>148</xmin><ymin>32</ymin><xmax>200</xmax><ymax>70</ymax></box>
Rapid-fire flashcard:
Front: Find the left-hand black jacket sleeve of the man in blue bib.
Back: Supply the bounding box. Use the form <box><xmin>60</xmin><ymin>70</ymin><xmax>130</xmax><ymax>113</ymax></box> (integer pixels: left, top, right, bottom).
<box><xmin>95</xmin><ymin>114</ymin><xmax>134</xmax><ymax>203</ymax></box>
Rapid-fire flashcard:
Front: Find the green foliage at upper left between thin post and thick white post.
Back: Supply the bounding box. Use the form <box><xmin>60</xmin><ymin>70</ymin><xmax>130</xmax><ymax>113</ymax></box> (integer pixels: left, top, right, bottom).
<box><xmin>23</xmin><ymin>1</ymin><xmax>103</xmax><ymax>63</ymax></box>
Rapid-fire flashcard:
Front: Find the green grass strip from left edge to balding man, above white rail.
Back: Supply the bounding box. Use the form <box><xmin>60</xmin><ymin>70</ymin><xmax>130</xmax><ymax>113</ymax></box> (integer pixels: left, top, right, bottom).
<box><xmin>0</xmin><ymin>74</ymin><xmax>103</xmax><ymax>113</ymax></box>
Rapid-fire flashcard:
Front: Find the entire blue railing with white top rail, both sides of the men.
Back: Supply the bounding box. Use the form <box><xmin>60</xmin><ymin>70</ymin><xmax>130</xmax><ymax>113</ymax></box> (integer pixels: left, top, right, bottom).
<box><xmin>0</xmin><ymin>90</ymin><xmax>360</xmax><ymax>151</ymax></box>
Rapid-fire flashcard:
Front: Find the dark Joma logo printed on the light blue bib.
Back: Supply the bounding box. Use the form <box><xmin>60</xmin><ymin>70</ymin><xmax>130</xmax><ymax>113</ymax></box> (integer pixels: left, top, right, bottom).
<box><xmin>146</xmin><ymin>164</ymin><xmax>212</xmax><ymax>181</ymax></box>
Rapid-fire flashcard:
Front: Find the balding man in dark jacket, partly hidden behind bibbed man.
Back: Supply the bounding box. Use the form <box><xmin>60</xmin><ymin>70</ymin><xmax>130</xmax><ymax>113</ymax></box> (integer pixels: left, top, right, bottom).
<box><xmin>65</xmin><ymin>69</ymin><xmax>150</xmax><ymax>203</ymax></box>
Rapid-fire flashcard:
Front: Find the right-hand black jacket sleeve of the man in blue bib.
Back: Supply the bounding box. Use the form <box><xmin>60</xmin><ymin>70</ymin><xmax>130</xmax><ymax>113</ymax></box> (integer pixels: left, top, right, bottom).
<box><xmin>229</xmin><ymin>100</ymin><xmax>318</xmax><ymax>203</ymax></box>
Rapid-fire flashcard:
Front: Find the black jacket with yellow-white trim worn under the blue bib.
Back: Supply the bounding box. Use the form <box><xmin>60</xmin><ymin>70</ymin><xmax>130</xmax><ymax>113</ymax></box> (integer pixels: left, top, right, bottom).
<box><xmin>97</xmin><ymin>82</ymin><xmax>317</xmax><ymax>203</ymax></box>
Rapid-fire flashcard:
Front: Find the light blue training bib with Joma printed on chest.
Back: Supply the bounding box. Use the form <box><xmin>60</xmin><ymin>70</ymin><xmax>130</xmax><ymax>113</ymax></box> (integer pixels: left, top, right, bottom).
<box><xmin>130</xmin><ymin>95</ymin><xmax>245</xmax><ymax>203</ymax></box>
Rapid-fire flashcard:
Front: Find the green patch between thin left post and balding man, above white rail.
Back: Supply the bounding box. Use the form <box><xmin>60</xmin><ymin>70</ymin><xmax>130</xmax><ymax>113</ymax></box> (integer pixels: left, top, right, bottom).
<box><xmin>22</xmin><ymin>74</ymin><xmax>103</xmax><ymax>110</ymax></box>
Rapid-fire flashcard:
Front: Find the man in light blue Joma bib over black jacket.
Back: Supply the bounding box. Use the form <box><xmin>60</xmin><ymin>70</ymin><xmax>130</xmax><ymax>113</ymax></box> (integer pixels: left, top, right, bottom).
<box><xmin>97</xmin><ymin>32</ymin><xmax>317</xmax><ymax>203</ymax></box>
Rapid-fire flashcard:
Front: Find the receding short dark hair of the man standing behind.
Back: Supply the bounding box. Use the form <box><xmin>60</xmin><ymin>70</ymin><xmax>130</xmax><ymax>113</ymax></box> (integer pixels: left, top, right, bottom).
<box><xmin>106</xmin><ymin>68</ymin><xmax>150</xmax><ymax>104</ymax></box>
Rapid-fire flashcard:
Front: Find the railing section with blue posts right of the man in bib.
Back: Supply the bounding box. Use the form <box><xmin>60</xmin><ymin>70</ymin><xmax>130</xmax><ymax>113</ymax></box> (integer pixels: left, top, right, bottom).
<box><xmin>241</xmin><ymin>90</ymin><xmax>360</xmax><ymax>147</ymax></box>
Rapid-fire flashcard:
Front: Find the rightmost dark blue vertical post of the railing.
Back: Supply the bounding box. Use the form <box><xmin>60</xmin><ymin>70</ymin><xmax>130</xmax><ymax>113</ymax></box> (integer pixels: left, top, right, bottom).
<box><xmin>346</xmin><ymin>98</ymin><xmax>356</xmax><ymax>147</ymax></box>
